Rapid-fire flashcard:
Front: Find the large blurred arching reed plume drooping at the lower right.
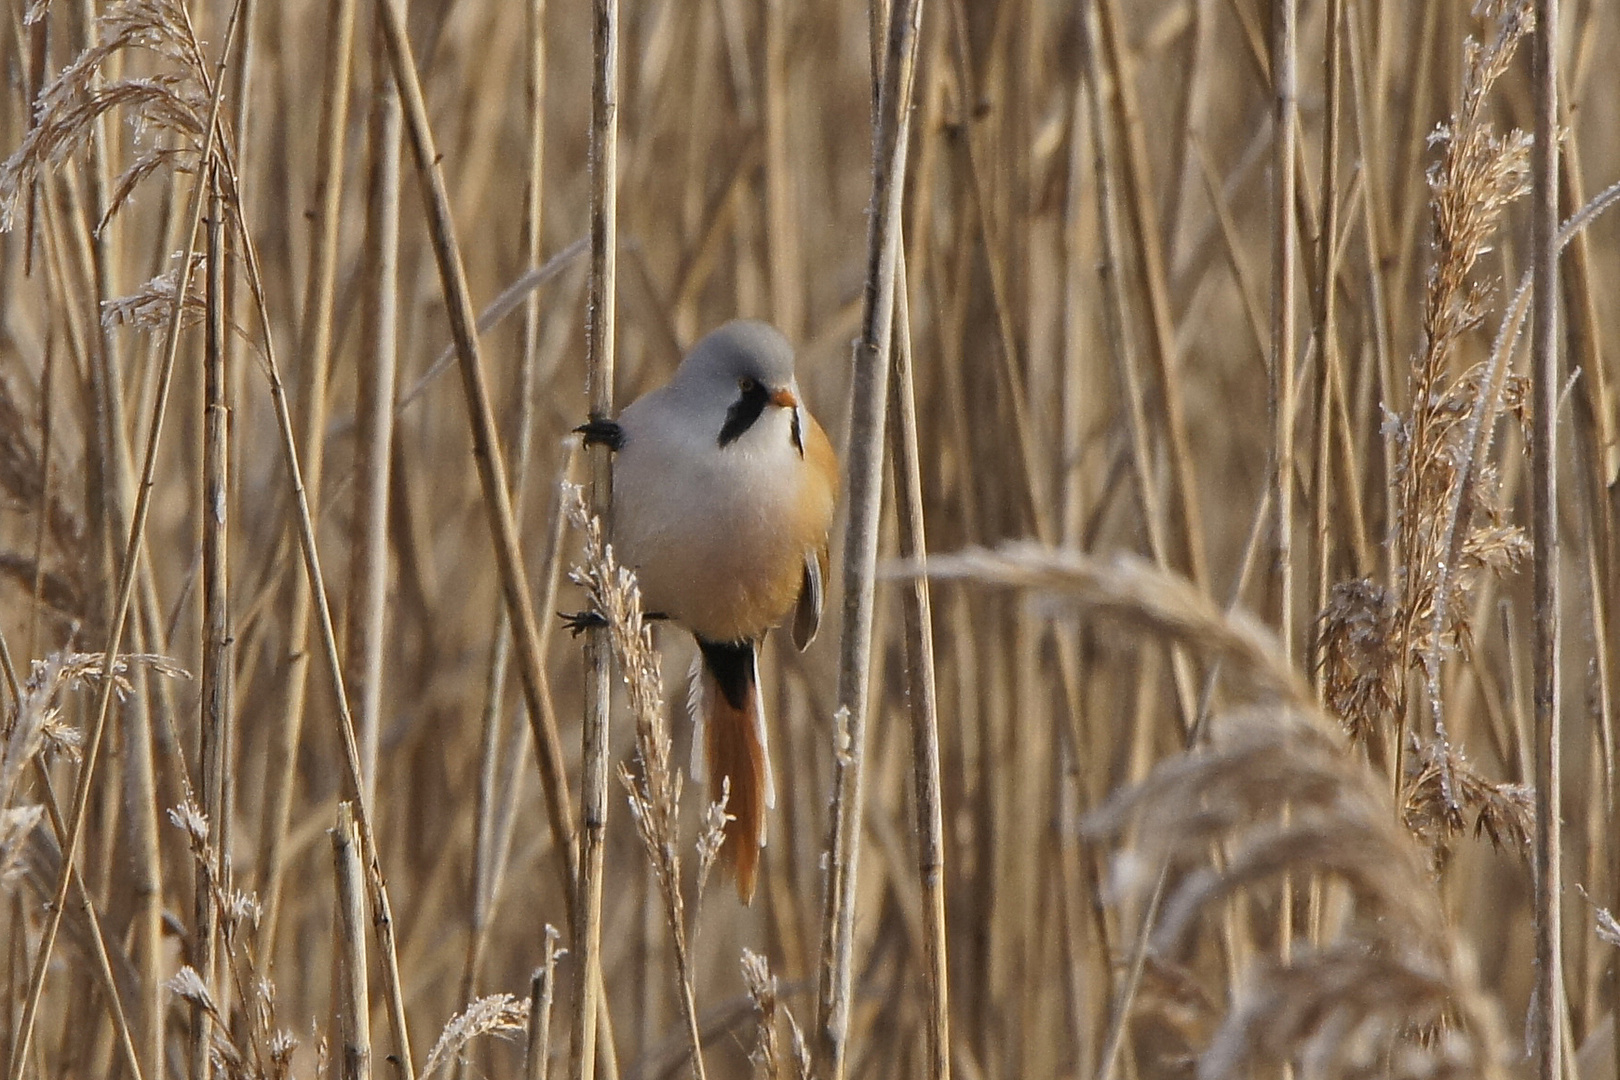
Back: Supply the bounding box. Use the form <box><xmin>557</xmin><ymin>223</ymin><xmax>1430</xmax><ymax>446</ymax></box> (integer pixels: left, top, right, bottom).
<box><xmin>927</xmin><ymin>546</ymin><xmax>1505</xmax><ymax>1080</ymax></box>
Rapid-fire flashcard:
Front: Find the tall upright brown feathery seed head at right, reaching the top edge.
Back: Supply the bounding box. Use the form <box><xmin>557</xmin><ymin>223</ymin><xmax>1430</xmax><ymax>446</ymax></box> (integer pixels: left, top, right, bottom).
<box><xmin>1317</xmin><ymin>0</ymin><xmax>1534</xmax><ymax>853</ymax></box>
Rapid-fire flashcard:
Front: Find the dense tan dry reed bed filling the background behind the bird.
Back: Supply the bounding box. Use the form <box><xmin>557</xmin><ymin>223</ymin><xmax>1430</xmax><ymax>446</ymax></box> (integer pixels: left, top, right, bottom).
<box><xmin>0</xmin><ymin>0</ymin><xmax>1620</xmax><ymax>1080</ymax></box>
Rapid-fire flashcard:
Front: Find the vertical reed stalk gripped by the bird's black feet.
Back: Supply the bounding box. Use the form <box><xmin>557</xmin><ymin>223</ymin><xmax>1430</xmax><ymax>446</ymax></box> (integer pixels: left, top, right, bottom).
<box><xmin>572</xmin><ymin>0</ymin><xmax>619</xmax><ymax>1080</ymax></box>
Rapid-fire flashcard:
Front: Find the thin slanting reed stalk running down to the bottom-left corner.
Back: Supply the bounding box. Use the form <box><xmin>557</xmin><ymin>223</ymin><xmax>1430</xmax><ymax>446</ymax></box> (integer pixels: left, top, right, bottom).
<box><xmin>6</xmin><ymin>0</ymin><xmax>241</xmax><ymax>1080</ymax></box>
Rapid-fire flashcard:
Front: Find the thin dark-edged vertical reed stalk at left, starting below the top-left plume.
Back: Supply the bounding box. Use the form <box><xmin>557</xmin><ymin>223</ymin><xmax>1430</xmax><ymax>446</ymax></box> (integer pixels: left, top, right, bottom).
<box><xmin>191</xmin><ymin>167</ymin><xmax>235</xmax><ymax>1080</ymax></box>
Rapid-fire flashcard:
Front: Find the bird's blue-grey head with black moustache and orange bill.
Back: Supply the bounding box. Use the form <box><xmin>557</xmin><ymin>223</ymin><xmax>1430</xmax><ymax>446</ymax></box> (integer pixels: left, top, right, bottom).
<box><xmin>672</xmin><ymin>319</ymin><xmax>799</xmax><ymax>447</ymax></box>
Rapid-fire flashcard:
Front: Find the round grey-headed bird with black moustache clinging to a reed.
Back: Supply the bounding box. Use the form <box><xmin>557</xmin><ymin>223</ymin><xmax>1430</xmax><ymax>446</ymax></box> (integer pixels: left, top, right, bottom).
<box><xmin>580</xmin><ymin>321</ymin><xmax>838</xmax><ymax>904</ymax></box>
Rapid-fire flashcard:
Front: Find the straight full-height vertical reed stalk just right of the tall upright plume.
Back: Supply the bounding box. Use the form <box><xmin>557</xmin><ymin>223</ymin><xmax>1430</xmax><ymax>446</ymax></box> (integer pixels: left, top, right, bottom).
<box><xmin>1531</xmin><ymin>0</ymin><xmax>1563</xmax><ymax>1080</ymax></box>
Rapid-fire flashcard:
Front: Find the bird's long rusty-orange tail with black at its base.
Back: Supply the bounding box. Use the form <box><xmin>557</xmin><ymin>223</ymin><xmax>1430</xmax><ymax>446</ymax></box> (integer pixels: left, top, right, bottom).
<box><xmin>692</xmin><ymin>641</ymin><xmax>776</xmax><ymax>904</ymax></box>
